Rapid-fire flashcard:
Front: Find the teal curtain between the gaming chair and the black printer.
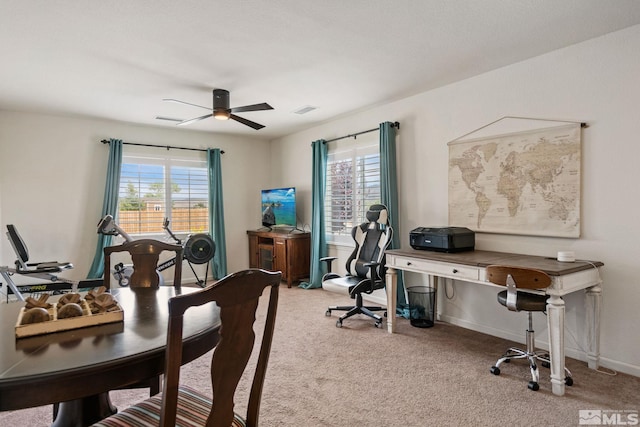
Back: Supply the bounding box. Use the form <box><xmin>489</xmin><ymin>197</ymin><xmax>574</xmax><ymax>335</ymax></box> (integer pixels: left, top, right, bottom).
<box><xmin>380</xmin><ymin>122</ymin><xmax>407</xmax><ymax>315</ymax></box>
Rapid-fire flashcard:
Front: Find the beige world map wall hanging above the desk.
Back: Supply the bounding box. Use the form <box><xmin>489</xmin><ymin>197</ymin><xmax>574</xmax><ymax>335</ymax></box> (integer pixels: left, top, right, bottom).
<box><xmin>448</xmin><ymin>123</ymin><xmax>581</xmax><ymax>238</ymax></box>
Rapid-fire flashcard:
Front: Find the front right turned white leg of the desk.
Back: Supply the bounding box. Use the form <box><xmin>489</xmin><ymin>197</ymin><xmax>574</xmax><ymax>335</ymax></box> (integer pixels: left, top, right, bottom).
<box><xmin>547</xmin><ymin>295</ymin><xmax>565</xmax><ymax>396</ymax></box>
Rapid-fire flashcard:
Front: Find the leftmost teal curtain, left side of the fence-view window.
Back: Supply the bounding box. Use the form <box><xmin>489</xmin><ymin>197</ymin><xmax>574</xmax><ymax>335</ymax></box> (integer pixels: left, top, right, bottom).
<box><xmin>87</xmin><ymin>138</ymin><xmax>122</xmax><ymax>279</ymax></box>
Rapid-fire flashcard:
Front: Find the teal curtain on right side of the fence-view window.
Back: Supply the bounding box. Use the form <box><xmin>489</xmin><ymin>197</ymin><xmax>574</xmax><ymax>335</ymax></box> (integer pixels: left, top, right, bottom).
<box><xmin>207</xmin><ymin>148</ymin><xmax>227</xmax><ymax>279</ymax></box>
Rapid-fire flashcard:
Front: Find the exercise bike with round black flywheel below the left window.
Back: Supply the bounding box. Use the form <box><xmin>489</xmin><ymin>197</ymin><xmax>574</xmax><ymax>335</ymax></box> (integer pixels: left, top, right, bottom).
<box><xmin>98</xmin><ymin>215</ymin><xmax>216</xmax><ymax>287</ymax></box>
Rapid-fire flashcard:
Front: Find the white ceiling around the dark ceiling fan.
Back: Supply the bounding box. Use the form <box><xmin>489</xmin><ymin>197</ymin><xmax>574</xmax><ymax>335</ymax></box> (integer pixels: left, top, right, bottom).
<box><xmin>0</xmin><ymin>0</ymin><xmax>640</xmax><ymax>138</ymax></box>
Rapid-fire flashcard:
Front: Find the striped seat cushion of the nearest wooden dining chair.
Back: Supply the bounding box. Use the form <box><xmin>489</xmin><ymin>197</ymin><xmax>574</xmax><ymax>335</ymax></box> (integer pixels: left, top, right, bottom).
<box><xmin>94</xmin><ymin>386</ymin><xmax>246</xmax><ymax>427</ymax></box>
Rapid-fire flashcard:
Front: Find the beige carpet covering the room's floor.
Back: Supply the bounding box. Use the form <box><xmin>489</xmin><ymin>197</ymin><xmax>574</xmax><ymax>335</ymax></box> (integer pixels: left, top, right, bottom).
<box><xmin>0</xmin><ymin>286</ymin><xmax>640</xmax><ymax>426</ymax></box>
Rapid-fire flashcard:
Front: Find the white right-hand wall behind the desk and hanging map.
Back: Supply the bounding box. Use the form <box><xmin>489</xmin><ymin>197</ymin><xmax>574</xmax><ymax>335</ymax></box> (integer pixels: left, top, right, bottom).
<box><xmin>271</xmin><ymin>26</ymin><xmax>640</xmax><ymax>376</ymax></box>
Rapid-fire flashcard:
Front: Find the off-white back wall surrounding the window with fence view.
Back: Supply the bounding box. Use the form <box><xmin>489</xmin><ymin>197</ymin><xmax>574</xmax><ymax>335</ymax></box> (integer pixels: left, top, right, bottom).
<box><xmin>0</xmin><ymin>111</ymin><xmax>269</xmax><ymax>283</ymax></box>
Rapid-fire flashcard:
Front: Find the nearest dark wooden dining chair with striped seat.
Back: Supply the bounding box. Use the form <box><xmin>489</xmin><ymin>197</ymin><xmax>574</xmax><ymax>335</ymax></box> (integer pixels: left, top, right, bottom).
<box><xmin>94</xmin><ymin>269</ymin><xmax>282</xmax><ymax>427</ymax></box>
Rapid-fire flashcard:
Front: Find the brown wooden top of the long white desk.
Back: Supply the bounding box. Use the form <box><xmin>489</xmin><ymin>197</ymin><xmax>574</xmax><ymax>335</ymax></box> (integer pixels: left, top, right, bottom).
<box><xmin>386</xmin><ymin>249</ymin><xmax>604</xmax><ymax>276</ymax></box>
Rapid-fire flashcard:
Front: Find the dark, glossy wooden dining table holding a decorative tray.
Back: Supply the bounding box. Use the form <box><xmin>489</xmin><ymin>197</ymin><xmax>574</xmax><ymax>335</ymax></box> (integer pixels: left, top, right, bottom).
<box><xmin>0</xmin><ymin>286</ymin><xmax>220</xmax><ymax>427</ymax></box>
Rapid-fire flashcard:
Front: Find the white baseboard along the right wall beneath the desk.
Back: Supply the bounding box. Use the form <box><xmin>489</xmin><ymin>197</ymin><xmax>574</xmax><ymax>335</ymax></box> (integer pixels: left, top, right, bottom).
<box><xmin>438</xmin><ymin>314</ymin><xmax>640</xmax><ymax>377</ymax></box>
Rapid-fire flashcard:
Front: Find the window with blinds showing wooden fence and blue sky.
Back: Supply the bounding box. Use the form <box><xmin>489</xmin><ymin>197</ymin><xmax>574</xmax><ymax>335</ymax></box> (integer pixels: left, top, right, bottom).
<box><xmin>118</xmin><ymin>155</ymin><xmax>209</xmax><ymax>234</ymax></box>
